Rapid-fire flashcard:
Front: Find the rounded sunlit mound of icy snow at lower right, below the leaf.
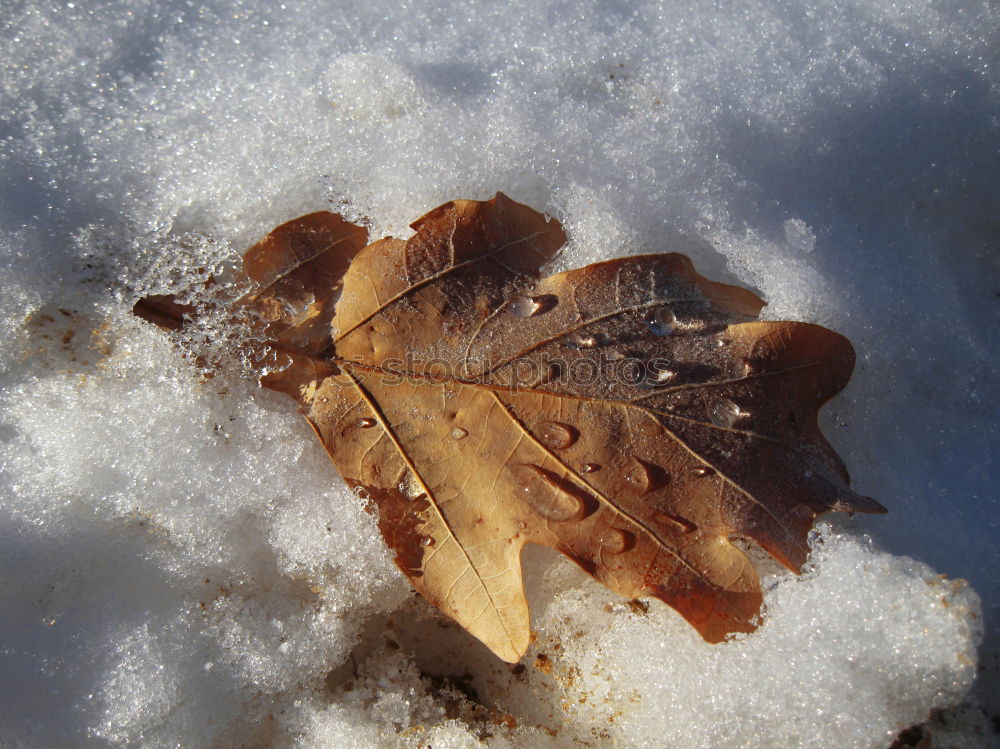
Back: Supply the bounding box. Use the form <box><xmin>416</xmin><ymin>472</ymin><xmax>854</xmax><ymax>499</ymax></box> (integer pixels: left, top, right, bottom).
<box><xmin>540</xmin><ymin>528</ymin><xmax>981</xmax><ymax>749</ymax></box>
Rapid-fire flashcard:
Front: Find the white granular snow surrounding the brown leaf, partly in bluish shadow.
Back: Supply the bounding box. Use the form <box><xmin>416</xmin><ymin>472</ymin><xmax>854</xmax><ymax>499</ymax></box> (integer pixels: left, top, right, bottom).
<box><xmin>0</xmin><ymin>0</ymin><xmax>1000</xmax><ymax>749</ymax></box>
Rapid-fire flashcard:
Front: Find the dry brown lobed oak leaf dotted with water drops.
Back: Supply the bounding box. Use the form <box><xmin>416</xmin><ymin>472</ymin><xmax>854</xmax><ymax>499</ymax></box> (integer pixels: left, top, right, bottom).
<box><xmin>133</xmin><ymin>194</ymin><xmax>884</xmax><ymax>661</ymax></box>
